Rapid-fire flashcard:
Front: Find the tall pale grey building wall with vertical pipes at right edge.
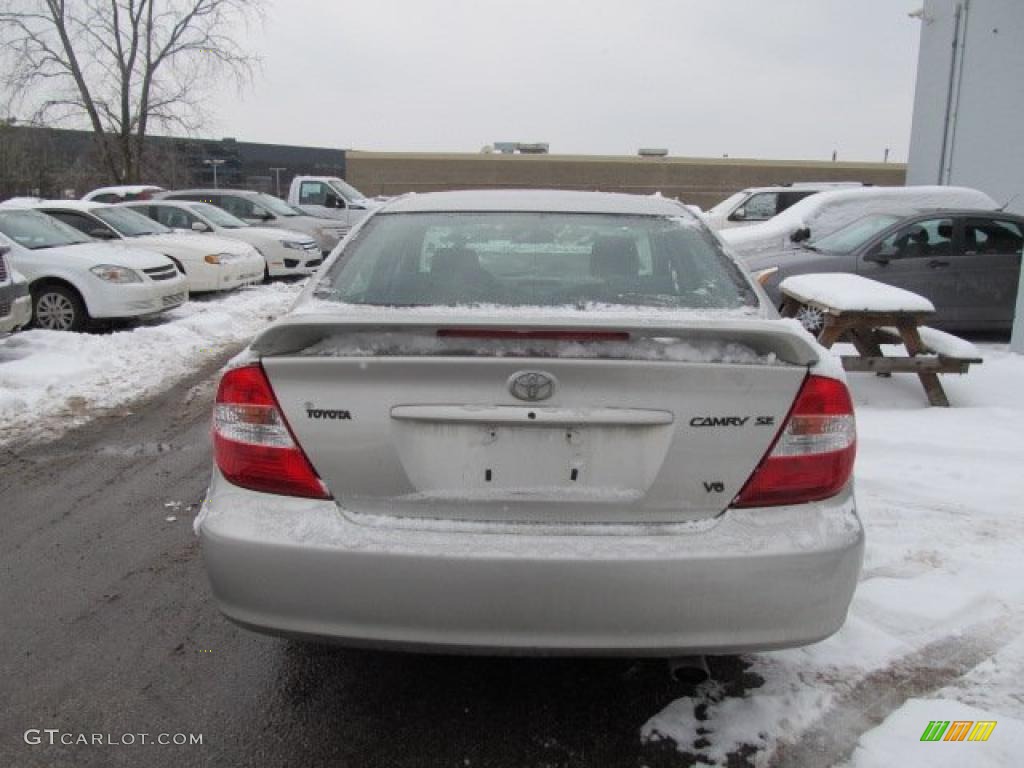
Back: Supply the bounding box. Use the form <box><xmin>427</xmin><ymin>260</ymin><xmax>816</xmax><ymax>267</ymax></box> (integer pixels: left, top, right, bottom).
<box><xmin>907</xmin><ymin>0</ymin><xmax>1024</xmax><ymax>213</ymax></box>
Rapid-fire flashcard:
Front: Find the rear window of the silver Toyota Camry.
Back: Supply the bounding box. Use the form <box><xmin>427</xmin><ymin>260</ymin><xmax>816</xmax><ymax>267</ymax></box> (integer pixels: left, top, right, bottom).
<box><xmin>317</xmin><ymin>213</ymin><xmax>757</xmax><ymax>308</ymax></box>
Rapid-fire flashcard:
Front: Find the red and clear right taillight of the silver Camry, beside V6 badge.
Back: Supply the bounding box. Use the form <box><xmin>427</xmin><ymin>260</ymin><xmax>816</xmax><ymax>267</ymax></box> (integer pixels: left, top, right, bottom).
<box><xmin>732</xmin><ymin>376</ymin><xmax>857</xmax><ymax>507</ymax></box>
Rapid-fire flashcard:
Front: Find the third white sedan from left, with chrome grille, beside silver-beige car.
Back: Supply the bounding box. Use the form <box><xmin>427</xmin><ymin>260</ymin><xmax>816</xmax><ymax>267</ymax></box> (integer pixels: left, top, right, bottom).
<box><xmin>123</xmin><ymin>200</ymin><xmax>324</xmax><ymax>278</ymax></box>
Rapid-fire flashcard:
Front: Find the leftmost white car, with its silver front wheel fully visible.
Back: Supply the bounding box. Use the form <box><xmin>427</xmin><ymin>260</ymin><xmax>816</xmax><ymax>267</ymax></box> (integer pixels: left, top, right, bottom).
<box><xmin>0</xmin><ymin>207</ymin><xmax>188</xmax><ymax>331</ymax></box>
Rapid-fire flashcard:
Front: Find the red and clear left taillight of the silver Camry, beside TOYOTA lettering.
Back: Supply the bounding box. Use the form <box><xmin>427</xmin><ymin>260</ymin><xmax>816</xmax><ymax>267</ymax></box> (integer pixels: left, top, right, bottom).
<box><xmin>213</xmin><ymin>365</ymin><xmax>331</xmax><ymax>499</ymax></box>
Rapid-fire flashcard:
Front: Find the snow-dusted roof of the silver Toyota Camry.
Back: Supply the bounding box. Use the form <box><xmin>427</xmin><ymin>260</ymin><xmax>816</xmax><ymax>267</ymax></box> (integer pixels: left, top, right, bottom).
<box><xmin>380</xmin><ymin>189</ymin><xmax>695</xmax><ymax>218</ymax></box>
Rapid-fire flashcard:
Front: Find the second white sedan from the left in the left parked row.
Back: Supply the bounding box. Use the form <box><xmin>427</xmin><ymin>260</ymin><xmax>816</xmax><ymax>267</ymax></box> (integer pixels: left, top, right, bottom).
<box><xmin>35</xmin><ymin>200</ymin><xmax>264</xmax><ymax>293</ymax></box>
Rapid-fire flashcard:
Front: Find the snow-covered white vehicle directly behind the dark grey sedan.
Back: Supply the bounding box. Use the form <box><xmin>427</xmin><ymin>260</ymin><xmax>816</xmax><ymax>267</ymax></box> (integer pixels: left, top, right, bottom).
<box><xmin>718</xmin><ymin>186</ymin><xmax>999</xmax><ymax>256</ymax></box>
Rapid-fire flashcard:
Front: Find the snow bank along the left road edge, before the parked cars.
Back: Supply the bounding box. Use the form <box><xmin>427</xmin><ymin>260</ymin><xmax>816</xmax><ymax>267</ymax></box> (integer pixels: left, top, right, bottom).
<box><xmin>0</xmin><ymin>283</ymin><xmax>301</xmax><ymax>445</ymax></box>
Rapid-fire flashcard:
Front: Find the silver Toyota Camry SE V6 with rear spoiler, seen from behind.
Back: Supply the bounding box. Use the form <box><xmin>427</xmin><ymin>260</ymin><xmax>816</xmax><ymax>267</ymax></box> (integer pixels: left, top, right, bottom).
<box><xmin>197</xmin><ymin>190</ymin><xmax>863</xmax><ymax>655</ymax></box>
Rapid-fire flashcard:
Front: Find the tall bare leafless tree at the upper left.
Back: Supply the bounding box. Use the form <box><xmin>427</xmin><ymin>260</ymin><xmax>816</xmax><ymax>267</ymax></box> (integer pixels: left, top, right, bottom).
<box><xmin>0</xmin><ymin>0</ymin><xmax>263</xmax><ymax>182</ymax></box>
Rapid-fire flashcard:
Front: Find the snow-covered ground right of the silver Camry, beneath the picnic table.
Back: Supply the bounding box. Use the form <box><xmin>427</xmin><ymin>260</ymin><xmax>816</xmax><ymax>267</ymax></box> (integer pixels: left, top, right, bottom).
<box><xmin>641</xmin><ymin>344</ymin><xmax>1024</xmax><ymax>768</ymax></box>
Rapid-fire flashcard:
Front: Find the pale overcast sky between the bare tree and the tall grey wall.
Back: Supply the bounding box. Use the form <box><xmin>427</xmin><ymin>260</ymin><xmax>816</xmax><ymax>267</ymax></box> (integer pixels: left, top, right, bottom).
<box><xmin>207</xmin><ymin>0</ymin><xmax>922</xmax><ymax>161</ymax></box>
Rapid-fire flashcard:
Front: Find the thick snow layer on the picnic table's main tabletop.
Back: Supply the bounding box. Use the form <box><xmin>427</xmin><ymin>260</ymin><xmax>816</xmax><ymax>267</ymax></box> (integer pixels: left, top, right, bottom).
<box><xmin>778</xmin><ymin>272</ymin><xmax>935</xmax><ymax>312</ymax></box>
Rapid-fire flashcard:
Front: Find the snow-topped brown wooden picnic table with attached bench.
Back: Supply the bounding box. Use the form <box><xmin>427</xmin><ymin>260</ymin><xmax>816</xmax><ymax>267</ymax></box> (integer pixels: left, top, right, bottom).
<box><xmin>779</xmin><ymin>273</ymin><xmax>982</xmax><ymax>407</ymax></box>
